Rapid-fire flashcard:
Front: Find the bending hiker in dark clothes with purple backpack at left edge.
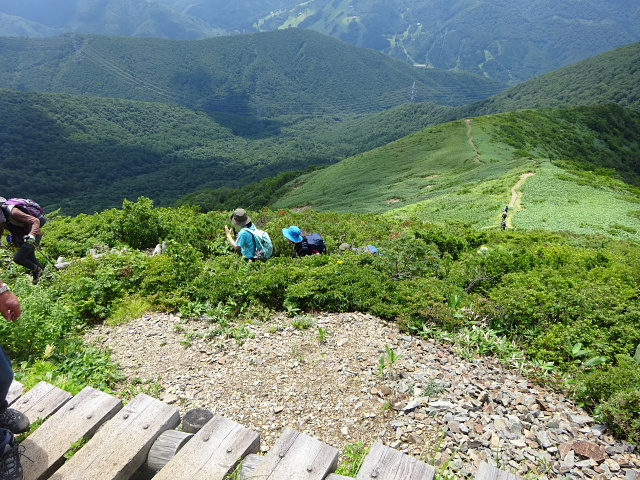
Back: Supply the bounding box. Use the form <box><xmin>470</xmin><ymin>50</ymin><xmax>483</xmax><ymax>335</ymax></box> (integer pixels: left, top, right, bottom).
<box><xmin>0</xmin><ymin>197</ymin><xmax>47</xmax><ymax>285</ymax></box>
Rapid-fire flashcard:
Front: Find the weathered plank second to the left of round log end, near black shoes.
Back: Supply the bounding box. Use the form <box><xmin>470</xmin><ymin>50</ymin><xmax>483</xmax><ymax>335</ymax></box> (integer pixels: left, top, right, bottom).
<box><xmin>21</xmin><ymin>387</ymin><xmax>122</xmax><ymax>480</ymax></box>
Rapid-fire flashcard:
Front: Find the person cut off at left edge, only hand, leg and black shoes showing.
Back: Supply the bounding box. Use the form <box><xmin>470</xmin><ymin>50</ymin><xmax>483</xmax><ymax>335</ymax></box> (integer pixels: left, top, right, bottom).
<box><xmin>0</xmin><ymin>281</ymin><xmax>30</xmax><ymax>479</ymax></box>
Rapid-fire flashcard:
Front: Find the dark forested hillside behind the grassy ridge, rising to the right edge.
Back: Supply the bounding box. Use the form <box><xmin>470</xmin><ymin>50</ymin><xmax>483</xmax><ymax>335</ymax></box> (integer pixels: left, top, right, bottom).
<box><xmin>0</xmin><ymin>39</ymin><xmax>640</xmax><ymax>214</ymax></box>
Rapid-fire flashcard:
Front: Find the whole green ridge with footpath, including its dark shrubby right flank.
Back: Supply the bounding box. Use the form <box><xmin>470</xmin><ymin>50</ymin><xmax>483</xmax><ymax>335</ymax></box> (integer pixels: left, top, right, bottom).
<box><xmin>273</xmin><ymin>106</ymin><xmax>640</xmax><ymax>239</ymax></box>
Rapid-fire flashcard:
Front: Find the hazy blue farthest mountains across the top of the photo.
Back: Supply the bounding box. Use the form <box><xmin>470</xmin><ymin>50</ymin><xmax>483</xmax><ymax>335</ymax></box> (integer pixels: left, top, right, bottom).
<box><xmin>0</xmin><ymin>0</ymin><xmax>640</xmax><ymax>84</ymax></box>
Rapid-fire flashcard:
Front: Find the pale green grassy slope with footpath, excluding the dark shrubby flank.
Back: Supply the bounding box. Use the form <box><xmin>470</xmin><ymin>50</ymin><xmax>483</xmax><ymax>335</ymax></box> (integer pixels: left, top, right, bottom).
<box><xmin>273</xmin><ymin>112</ymin><xmax>640</xmax><ymax>240</ymax></box>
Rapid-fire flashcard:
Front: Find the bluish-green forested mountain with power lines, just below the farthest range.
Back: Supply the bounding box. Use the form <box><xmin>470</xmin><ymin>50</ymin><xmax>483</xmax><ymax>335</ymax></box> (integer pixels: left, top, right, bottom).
<box><xmin>0</xmin><ymin>29</ymin><xmax>503</xmax><ymax>116</ymax></box>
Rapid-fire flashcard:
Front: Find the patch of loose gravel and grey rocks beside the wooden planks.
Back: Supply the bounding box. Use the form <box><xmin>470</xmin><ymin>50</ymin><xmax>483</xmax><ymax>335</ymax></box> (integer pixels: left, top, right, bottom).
<box><xmin>86</xmin><ymin>313</ymin><xmax>640</xmax><ymax>480</ymax></box>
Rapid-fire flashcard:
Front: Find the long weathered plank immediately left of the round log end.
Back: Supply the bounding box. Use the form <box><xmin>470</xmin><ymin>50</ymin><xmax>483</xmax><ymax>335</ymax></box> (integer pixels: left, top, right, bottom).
<box><xmin>51</xmin><ymin>393</ymin><xmax>180</xmax><ymax>480</ymax></box>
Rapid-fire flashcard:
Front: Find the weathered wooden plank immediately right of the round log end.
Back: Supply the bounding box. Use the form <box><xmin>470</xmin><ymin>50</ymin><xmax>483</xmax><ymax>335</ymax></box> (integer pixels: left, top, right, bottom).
<box><xmin>153</xmin><ymin>415</ymin><xmax>260</xmax><ymax>480</ymax></box>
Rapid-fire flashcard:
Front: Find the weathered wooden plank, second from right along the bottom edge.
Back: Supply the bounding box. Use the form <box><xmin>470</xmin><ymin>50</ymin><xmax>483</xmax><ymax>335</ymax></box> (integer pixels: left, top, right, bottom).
<box><xmin>356</xmin><ymin>442</ymin><xmax>436</xmax><ymax>480</ymax></box>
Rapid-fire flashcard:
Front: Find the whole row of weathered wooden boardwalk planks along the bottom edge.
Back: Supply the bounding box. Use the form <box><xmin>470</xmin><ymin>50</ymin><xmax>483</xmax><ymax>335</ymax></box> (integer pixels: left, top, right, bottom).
<box><xmin>9</xmin><ymin>382</ymin><xmax>522</xmax><ymax>480</ymax></box>
